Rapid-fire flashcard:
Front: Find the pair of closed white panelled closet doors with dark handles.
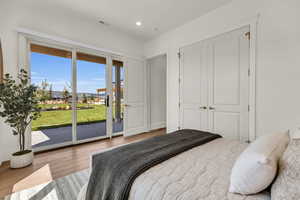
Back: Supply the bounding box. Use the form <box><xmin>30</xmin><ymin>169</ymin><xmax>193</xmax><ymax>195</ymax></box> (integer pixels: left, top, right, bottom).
<box><xmin>179</xmin><ymin>26</ymin><xmax>250</xmax><ymax>141</ymax></box>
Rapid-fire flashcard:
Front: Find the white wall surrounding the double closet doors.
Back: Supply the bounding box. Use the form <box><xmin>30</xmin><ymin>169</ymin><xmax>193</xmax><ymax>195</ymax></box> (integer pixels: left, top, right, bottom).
<box><xmin>145</xmin><ymin>0</ymin><xmax>300</xmax><ymax>136</ymax></box>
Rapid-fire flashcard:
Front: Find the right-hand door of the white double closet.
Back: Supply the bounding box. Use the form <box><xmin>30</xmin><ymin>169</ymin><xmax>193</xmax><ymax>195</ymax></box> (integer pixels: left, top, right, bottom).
<box><xmin>208</xmin><ymin>27</ymin><xmax>249</xmax><ymax>141</ymax></box>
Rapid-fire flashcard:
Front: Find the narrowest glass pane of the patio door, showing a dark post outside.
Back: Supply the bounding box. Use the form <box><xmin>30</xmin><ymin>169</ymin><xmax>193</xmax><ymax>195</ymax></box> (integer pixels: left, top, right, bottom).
<box><xmin>112</xmin><ymin>60</ymin><xmax>124</xmax><ymax>135</ymax></box>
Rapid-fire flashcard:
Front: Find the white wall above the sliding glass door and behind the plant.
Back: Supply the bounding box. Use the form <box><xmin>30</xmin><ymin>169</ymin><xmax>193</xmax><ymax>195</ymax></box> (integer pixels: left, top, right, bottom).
<box><xmin>0</xmin><ymin>0</ymin><xmax>143</xmax><ymax>163</ymax></box>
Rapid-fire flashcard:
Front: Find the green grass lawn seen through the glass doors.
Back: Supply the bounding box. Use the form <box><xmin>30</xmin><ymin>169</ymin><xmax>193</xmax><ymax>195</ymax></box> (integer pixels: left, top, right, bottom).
<box><xmin>32</xmin><ymin>104</ymin><xmax>106</xmax><ymax>130</ymax></box>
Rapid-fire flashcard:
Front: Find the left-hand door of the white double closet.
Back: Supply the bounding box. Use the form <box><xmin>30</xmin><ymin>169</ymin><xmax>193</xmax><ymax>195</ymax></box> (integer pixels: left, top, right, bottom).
<box><xmin>180</xmin><ymin>43</ymin><xmax>208</xmax><ymax>130</ymax></box>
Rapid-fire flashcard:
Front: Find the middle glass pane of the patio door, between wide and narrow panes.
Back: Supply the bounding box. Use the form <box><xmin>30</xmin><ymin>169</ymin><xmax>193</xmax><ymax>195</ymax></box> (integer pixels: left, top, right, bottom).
<box><xmin>76</xmin><ymin>52</ymin><xmax>108</xmax><ymax>140</ymax></box>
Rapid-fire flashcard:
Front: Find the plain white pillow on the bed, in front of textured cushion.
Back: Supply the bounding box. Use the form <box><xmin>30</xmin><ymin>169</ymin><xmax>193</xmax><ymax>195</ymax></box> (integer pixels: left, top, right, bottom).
<box><xmin>229</xmin><ymin>132</ymin><xmax>289</xmax><ymax>195</ymax></box>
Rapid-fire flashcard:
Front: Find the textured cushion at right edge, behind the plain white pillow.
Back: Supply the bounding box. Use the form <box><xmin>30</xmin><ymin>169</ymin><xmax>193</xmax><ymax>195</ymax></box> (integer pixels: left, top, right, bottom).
<box><xmin>271</xmin><ymin>131</ymin><xmax>300</xmax><ymax>200</ymax></box>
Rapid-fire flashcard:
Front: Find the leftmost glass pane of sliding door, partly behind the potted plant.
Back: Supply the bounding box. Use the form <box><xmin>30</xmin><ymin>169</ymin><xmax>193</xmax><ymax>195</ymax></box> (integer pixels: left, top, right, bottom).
<box><xmin>30</xmin><ymin>44</ymin><xmax>72</xmax><ymax>149</ymax></box>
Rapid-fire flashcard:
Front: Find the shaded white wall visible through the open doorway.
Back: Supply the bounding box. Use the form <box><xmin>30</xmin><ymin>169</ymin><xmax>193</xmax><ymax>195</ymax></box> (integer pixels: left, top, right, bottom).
<box><xmin>147</xmin><ymin>55</ymin><xmax>167</xmax><ymax>130</ymax></box>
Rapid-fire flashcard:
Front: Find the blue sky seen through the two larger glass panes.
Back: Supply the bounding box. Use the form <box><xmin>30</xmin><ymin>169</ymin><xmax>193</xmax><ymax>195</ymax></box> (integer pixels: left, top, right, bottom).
<box><xmin>31</xmin><ymin>52</ymin><xmax>106</xmax><ymax>93</ymax></box>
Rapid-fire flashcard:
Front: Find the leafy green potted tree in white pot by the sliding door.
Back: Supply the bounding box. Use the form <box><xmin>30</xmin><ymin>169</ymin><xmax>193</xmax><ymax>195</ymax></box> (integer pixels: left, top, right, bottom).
<box><xmin>0</xmin><ymin>69</ymin><xmax>40</xmax><ymax>168</ymax></box>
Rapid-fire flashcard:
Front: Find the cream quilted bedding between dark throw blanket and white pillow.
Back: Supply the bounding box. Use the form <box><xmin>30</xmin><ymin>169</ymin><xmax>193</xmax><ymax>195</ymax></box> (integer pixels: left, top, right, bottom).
<box><xmin>78</xmin><ymin>138</ymin><xmax>271</xmax><ymax>200</ymax></box>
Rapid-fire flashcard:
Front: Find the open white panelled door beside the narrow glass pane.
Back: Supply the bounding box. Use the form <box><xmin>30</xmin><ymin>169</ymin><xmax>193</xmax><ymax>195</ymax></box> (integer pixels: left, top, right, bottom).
<box><xmin>124</xmin><ymin>59</ymin><xmax>146</xmax><ymax>136</ymax></box>
